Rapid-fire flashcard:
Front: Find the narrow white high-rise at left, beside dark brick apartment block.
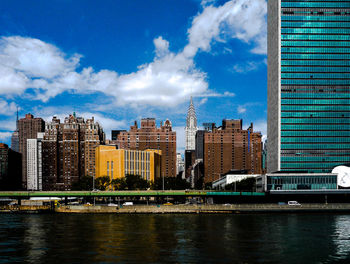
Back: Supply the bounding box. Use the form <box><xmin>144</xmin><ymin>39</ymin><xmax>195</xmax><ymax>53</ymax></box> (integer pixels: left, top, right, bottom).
<box><xmin>27</xmin><ymin>133</ymin><xmax>44</xmax><ymax>191</ymax></box>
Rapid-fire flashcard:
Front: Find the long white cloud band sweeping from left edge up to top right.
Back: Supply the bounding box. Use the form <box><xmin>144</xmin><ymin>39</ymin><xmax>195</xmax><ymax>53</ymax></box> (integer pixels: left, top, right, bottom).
<box><xmin>0</xmin><ymin>0</ymin><xmax>266</xmax><ymax>107</ymax></box>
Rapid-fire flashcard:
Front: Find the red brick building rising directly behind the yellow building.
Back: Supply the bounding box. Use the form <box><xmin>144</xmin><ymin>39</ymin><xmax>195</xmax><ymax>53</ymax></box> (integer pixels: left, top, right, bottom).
<box><xmin>117</xmin><ymin>118</ymin><xmax>176</xmax><ymax>177</ymax></box>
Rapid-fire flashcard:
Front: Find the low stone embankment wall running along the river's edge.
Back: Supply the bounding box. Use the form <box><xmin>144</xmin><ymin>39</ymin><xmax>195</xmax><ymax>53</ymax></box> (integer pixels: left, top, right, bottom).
<box><xmin>0</xmin><ymin>204</ymin><xmax>350</xmax><ymax>214</ymax></box>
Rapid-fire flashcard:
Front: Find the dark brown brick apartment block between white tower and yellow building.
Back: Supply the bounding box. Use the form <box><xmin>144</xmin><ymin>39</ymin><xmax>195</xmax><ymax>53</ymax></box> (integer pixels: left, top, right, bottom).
<box><xmin>42</xmin><ymin>114</ymin><xmax>104</xmax><ymax>190</ymax></box>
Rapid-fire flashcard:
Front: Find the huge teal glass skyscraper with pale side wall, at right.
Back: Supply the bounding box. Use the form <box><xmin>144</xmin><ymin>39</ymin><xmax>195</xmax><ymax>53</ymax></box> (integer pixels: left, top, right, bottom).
<box><xmin>267</xmin><ymin>0</ymin><xmax>350</xmax><ymax>173</ymax></box>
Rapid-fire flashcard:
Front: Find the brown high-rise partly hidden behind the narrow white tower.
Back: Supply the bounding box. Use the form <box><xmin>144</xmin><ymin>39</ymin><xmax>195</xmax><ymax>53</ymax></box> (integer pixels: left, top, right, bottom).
<box><xmin>18</xmin><ymin>114</ymin><xmax>45</xmax><ymax>190</ymax></box>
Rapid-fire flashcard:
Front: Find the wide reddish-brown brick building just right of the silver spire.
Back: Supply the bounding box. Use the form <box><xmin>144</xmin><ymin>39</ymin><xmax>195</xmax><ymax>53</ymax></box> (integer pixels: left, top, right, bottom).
<box><xmin>204</xmin><ymin>120</ymin><xmax>262</xmax><ymax>183</ymax></box>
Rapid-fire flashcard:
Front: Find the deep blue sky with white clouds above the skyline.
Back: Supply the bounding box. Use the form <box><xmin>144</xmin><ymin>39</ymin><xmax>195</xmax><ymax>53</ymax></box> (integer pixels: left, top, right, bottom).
<box><xmin>0</xmin><ymin>0</ymin><xmax>267</xmax><ymax>152</ymax></box>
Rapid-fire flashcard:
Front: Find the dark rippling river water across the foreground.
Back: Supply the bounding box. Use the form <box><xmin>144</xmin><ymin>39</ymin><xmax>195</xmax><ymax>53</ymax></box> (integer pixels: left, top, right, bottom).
<box><xmin>0</xmin><ymin>214</ymin><xmax>350</xmax><ymax>264</ymax></box>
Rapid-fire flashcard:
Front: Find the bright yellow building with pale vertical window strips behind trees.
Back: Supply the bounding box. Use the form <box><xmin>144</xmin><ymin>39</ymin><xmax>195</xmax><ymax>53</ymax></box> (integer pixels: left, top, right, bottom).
<box><xmin>95</xmin><ymin>145</ymin><xmax>162</xmax><ymax>181</ymax></box>
